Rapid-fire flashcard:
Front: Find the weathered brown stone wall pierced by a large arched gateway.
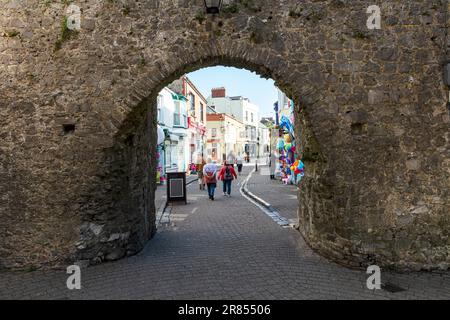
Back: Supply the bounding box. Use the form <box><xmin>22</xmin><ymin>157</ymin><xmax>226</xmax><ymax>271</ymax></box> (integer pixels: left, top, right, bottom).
<box><xmin>0</xmin><ymin>0</ymin><xmax>450</xmax><ymax>269</ymax></box>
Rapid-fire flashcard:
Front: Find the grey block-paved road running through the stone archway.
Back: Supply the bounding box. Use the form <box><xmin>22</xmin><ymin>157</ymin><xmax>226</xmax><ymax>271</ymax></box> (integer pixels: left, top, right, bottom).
<box><xmin>0</xmin><ymin>167</ymin><xmax>450</xmax><ymax>300</ymax></box>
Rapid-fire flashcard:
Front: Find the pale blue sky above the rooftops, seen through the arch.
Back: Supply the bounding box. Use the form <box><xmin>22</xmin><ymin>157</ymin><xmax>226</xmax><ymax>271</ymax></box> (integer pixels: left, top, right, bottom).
<box><xmin>187</xmin><ymin>66</ymin><xmax>278</xmax><ymax>117</ymax></box>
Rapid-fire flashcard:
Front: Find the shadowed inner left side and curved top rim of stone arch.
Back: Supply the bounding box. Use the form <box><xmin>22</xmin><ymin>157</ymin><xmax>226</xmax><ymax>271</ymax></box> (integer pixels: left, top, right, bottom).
<box><xmin>76</xmin><ymin>51</ymin><xmax>320</xmax><ymax>261</ymax></box>
